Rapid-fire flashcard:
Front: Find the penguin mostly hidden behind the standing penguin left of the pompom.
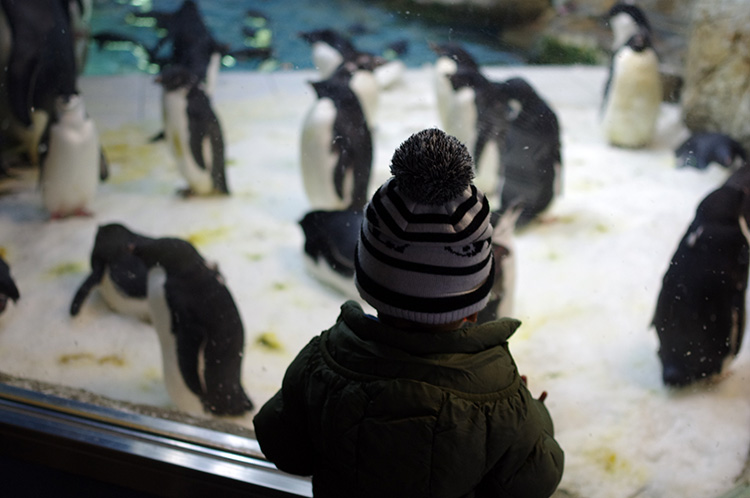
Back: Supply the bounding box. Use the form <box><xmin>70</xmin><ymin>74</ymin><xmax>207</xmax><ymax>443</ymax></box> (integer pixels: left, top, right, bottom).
<box><xmin>299</xmin><ymin>29</ymin><xmax>385</xmax><ymax>126</ymax></box>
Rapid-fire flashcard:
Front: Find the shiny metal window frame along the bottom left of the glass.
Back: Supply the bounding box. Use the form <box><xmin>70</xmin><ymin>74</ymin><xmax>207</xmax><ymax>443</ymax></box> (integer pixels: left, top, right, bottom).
<box><xmin>0</xmin><ymin>383</ymin><xmax>312</xmax><ymax>497</ymax></box>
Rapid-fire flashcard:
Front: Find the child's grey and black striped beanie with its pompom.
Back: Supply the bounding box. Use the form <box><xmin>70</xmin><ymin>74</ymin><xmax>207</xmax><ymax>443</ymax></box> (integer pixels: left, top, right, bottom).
<box><xmin>355</xmin><ymin>129</ymin><xmax>494</xmax><ymax>325</ymax></box>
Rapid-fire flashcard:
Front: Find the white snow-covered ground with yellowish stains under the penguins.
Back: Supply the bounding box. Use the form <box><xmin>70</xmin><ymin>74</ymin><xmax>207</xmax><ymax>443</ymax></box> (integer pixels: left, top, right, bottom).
<box><xmin>0</xmin><ymin>67</ymin><xmax>750</xmax><ymax>498</ymax></box>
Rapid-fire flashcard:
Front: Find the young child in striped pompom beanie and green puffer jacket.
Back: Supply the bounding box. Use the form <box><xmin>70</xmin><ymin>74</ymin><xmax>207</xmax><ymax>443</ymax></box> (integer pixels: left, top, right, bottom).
<box><xmin>254</xmin><ymin>129</ymin><xmax>563</xmax><ymax>498</ymax></box>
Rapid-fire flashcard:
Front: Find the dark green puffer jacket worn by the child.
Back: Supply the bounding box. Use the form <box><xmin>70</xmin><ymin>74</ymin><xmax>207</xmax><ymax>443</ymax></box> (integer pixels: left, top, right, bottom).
<box><xmin>254</xmin><ymin>301</ymin><xmax>563</xmax><ymax>498</ymax></box>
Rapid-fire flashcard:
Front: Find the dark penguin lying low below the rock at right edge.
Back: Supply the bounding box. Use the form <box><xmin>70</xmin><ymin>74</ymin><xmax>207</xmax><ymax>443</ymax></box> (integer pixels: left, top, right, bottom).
<box><xmin>674</xmin><ymin>132</ymin><xmax>747</xmax><ymax>170</ymax></box>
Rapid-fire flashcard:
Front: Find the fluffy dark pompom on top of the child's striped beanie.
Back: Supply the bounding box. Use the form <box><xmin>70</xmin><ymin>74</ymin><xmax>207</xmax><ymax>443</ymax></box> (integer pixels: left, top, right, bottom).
<box><xmin>391</xmin><ymin>128</ymin><xmax>474</xmax><ymax>205</ymax></box>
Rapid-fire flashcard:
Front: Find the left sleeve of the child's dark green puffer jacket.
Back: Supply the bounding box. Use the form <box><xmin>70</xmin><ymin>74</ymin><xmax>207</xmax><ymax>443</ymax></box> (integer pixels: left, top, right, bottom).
<box><xmin>253</xmin><ymin>337</ymin><xmax>318</xmax><ymax>476</ymax></box>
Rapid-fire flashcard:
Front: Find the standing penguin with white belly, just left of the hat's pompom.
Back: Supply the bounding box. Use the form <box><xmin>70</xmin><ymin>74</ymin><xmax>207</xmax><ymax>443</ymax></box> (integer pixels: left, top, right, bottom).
<box><xmin>300</xmin><ymin>63</ymin><xmax>373</xmax><ymax>211</ymax></box>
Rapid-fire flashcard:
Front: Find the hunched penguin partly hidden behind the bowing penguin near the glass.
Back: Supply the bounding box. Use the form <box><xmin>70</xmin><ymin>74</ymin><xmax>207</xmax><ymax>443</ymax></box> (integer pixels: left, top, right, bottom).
<box><xmin>70</xmin><ymin>223</ymin><xmax>153</xmax><ymax>321</ymax></box>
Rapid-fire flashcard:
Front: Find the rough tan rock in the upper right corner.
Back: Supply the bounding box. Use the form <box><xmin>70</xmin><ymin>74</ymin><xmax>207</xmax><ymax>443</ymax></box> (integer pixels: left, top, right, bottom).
<box><xmin>682</xmin><ymin>0</ymin><xmax>750</xmax><ymax>154</ymax></box>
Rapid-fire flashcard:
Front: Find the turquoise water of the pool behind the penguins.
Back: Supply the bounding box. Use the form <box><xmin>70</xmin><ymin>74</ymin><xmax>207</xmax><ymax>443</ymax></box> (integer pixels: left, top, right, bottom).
<box><xmin>85</xmin><ymin>0</ymin><xmax>523</xmax><ymax>75</ymax></box>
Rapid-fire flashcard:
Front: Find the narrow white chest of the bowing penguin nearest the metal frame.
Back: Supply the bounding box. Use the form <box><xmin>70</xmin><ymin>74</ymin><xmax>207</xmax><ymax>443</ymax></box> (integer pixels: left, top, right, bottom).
<box><xmin>147</xmin><ymin>266</ymin><xmax>203</xmax><ymax>414</ymax></box>
